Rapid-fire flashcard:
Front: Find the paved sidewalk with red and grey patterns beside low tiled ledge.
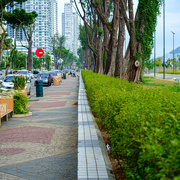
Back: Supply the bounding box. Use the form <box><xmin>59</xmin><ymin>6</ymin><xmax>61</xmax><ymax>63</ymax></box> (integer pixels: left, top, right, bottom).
<box><xmin>0</xmin><ymin>77</ymin><xmax>79</xmax><ymax>180</ymax></box>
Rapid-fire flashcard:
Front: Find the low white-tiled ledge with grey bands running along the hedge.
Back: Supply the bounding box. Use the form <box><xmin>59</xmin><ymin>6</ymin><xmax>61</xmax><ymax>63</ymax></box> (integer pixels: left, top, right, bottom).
<box><xmin>78</xmin><ymin>73</ymin><xmax>115</xmax><ymax>180</ymax></box>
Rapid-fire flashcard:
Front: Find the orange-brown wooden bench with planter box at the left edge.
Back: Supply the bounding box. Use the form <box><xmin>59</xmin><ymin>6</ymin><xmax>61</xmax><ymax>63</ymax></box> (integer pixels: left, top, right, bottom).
<box><xmin>0</xmin><ymin>94</ymin><xmax>13</xmax><ymax>126</ymax></box>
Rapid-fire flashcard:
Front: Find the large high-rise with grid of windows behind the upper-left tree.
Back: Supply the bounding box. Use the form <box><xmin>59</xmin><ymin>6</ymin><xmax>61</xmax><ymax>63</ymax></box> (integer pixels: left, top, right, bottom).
<box><xmin>8</xmin><ymin>0</ymin><xmax>58</xmax><ymax>52</ymax></box>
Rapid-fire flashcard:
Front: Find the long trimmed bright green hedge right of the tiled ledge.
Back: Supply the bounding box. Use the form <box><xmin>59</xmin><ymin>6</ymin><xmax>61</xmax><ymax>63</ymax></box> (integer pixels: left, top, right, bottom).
<box><xmin>81</xmin><ymin>71</ymin><xmax>180</xmax><ymax>180</ymax></box>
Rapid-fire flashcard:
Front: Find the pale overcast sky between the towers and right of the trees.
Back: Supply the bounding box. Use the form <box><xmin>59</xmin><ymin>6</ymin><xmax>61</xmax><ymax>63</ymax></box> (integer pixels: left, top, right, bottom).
<box><xmin>57</xmin><ymin>0</ymin><xmax>180</xmax><ymax>57</ymax></box>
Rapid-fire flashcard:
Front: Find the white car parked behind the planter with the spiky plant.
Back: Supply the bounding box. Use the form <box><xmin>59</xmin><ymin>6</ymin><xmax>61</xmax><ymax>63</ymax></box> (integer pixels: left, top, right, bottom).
<box><xmin>1</xmin><ymin>74</ymin><xmax>31</xmax><ymax>95</ymax></box>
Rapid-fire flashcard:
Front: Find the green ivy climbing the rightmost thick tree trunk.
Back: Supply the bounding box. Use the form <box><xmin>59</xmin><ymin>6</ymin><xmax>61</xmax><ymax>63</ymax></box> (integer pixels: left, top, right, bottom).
<box><xmin>135</xmin><ymin>0</ymin><xmax>161</xmax><ymax>70</ymax></box>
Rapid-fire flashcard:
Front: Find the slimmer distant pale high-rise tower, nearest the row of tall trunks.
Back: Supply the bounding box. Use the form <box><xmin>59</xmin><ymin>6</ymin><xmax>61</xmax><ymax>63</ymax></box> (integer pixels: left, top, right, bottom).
<box><xmin>62</xmin><ymin>3</ymin><xmax>79</xmax><ymax>56</ymax></box>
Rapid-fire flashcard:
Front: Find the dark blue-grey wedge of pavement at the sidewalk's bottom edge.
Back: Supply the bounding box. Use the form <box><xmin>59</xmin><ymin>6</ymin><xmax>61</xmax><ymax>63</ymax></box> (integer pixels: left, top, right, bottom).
<box><xmin>0</xmin><ymin>151</ymin><xmax>77</xmax><ymax>180</ymax></box>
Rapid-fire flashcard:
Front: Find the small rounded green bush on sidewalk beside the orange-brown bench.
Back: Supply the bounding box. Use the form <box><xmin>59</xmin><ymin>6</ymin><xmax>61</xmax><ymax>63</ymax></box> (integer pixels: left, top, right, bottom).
<box><xmin>13</xmin><ymin>93</ymin><xmax>29</xmax><ymax>114</ymax></box>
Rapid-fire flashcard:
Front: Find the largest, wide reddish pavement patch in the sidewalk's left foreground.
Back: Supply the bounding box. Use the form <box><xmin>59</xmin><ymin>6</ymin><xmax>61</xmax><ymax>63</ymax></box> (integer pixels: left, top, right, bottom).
<box><xmin>0</xmin><ymin>126</ymin><xmax>55</xmax><ymax>144</ymax></box>
